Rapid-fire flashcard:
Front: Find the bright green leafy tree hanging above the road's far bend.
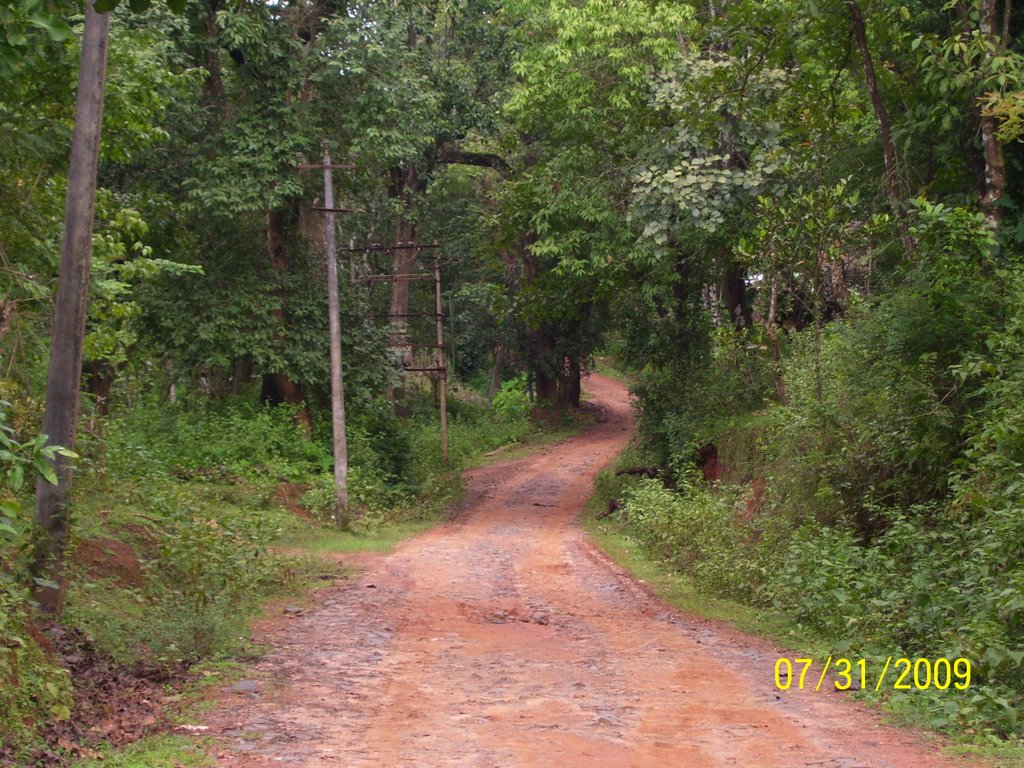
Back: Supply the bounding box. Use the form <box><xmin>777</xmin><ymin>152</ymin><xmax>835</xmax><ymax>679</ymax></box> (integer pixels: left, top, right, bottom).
<box><xmin>503</xmin><ymin>0</ymin><xmax>691</xmax><ymax>407</ymax></box>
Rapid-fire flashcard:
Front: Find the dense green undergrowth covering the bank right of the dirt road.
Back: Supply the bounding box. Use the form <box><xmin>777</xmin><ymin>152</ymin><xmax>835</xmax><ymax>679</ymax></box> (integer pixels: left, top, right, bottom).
<box><xmin>620</xmin><ymin>260</ymin><xmax>1024</xmax><ymax>741</ymax></box>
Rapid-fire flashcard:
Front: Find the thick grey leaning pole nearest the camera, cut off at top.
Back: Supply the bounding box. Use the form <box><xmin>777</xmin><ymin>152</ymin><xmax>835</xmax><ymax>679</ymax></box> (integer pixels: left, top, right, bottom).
<box><xmin>32</xmin><ymin>0</ymin><xmax>110</xmax><ymax>613</ymax></box>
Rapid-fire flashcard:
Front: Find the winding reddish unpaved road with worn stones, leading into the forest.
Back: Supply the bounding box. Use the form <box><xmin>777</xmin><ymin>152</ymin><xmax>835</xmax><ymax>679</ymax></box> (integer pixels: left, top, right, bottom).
<box><xmin>202</xmin><ymin>376</ymin><xmax>966</xmax><ymax>768</ymax></box>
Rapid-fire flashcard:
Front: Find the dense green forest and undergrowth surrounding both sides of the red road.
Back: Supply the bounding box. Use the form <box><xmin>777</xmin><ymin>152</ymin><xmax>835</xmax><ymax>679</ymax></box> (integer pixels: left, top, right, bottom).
<box><xmin>0</xmin><ymin>0</ymin><xmax>1024</xmax><ymax>760</ymax></box>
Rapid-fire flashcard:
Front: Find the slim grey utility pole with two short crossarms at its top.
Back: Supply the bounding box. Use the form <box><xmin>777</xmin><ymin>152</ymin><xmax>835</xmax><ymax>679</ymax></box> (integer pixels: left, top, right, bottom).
<box><xmin>299</xmin><ymin>140</ymin><xmax>352</xmax><ymax>528</ymax></box>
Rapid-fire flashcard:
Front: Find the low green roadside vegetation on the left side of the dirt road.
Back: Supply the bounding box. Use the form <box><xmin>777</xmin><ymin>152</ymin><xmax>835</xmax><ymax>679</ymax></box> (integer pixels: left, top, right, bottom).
<box><xmin>0</xmin><ymin>382</ymin><xmax>568</xmax><ymax>766</ymax></box>
